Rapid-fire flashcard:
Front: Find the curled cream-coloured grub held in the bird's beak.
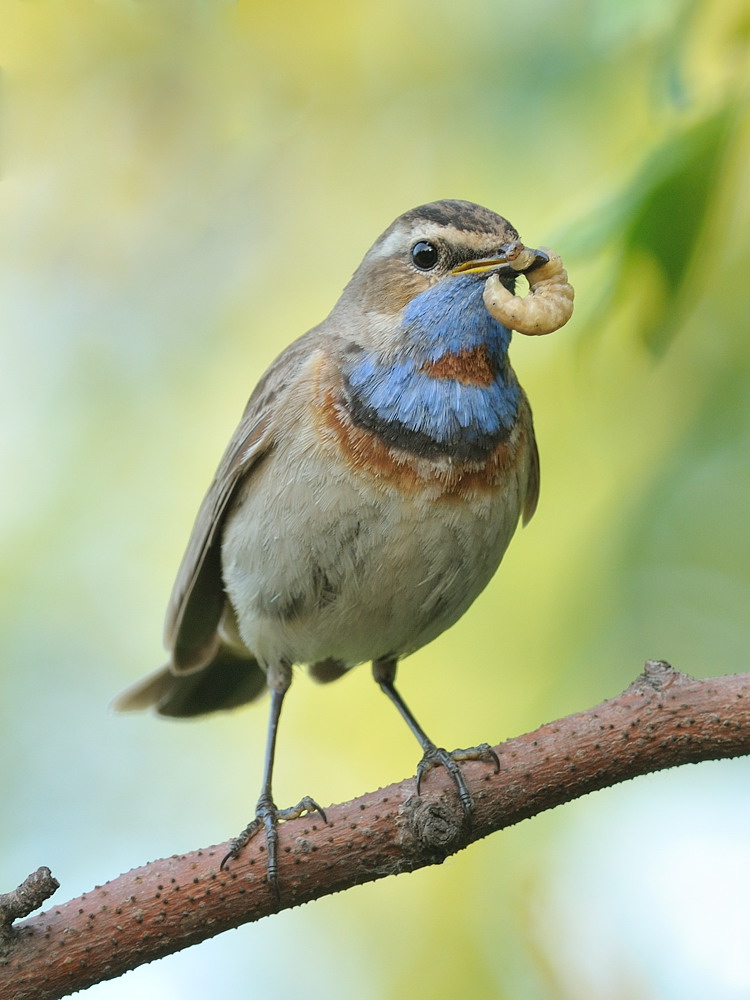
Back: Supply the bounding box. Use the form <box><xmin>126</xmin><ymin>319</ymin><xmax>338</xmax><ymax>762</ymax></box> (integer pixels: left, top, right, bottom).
<box><xmin>484</xmin><ymin>246</ymin><xmax>574</xmax><ymax>337</ymax></box>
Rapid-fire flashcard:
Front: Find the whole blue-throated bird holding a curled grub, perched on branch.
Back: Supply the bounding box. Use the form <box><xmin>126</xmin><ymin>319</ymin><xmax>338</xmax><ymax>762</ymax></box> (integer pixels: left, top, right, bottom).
<box><xmin>117</xmin><ymin>201</ymin><xmax>573</xmax><ymax>896</ymax></box>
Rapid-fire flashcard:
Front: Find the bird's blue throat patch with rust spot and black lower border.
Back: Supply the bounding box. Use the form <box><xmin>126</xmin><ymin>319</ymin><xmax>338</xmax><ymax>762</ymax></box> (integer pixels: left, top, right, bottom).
<box><xmin>345</xmin><ymin>275</ymin><xmax>520</xmax><ymax>460</ymax></box>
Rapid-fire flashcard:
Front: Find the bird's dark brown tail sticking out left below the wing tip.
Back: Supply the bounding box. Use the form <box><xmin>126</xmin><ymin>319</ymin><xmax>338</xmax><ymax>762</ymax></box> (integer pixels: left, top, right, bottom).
<box><xmin>114</xmin><ymin>646</ymin><xmax>266</xmax><ymax>718</ymax></box>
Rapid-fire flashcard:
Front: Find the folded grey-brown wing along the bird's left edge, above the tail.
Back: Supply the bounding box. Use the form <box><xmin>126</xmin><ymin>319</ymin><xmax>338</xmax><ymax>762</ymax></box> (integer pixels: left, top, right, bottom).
<box><xmin>164</xmin><ymin>399</ymin><xmax>271</xmax><ymax>672</ymax></box>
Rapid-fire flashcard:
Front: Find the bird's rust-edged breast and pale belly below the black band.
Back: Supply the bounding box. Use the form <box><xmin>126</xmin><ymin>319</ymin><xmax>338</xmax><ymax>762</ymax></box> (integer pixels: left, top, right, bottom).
<box><xmin>222</xmin><ymin>352</ymin><xmax>534</xmax><ymax>667</ymax></box>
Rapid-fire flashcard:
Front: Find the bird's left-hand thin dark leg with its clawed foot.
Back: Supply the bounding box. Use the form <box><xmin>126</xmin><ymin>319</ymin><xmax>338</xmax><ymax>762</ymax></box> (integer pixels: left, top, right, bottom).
<box><xmin>220</xmin><ymin>663</ymin><xmax>328</xmax><ymax>902</ymax></box>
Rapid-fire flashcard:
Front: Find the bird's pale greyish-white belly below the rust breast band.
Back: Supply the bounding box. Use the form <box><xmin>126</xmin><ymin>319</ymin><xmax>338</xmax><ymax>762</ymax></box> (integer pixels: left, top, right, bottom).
<box><xmin>222</xmin><ymin>430</ymin><xmax>523</xmax><ymax>666</ymax></box>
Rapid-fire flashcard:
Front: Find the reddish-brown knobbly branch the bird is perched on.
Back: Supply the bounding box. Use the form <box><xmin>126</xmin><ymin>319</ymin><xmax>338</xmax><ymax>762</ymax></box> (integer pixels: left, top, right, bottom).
<box><xmin>0</xmin><ymin>661</ymin><xmax>750</xmax><ymax>1000</ymax></box>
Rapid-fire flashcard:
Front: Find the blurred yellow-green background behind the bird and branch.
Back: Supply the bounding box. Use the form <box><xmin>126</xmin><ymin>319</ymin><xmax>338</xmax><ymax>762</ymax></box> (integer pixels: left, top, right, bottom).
<box><xmin>0</xmin><ymin>0</ymin><xmax>750</xmax><ymax>1000</ymax></box>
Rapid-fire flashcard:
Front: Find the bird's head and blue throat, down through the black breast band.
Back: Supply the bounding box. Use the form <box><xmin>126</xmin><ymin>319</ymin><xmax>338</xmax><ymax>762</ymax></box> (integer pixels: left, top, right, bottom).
<box><xmin>332</xmin><ymin>201</ymin><xmax>547</xmax><ymax>459</ymax></box>
